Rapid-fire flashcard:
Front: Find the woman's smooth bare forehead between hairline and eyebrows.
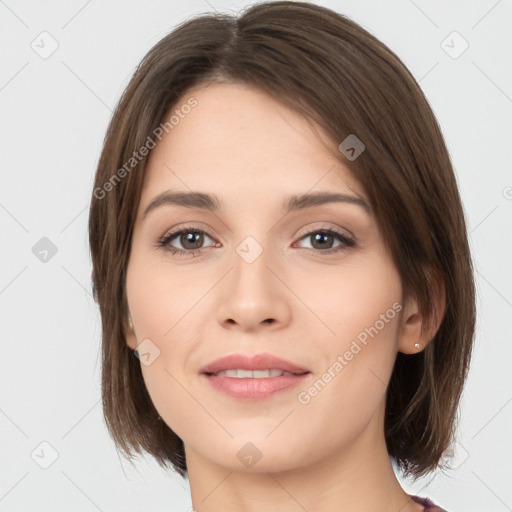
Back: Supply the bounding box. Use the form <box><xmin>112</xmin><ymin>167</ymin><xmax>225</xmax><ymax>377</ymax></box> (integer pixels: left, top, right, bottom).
<box><xmin>143</xmin><ymin>83</ymin><xmax>364</xmax><ymax>203</ymax></box>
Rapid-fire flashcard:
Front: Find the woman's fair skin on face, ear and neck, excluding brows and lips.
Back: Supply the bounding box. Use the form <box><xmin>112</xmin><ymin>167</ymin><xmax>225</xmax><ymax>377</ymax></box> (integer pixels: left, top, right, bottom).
<box><xmin>122</xmin><ymin>83</ymin><xmax>435</xmax><ymax>512</ymax></box>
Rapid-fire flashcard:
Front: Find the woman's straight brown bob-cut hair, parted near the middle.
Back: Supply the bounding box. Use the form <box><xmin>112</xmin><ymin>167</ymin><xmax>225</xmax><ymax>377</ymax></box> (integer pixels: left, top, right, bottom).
<box><xmin>89</xmin><ymin>1</ymin><xmax>475</xmax><ymax>478</ymax></box>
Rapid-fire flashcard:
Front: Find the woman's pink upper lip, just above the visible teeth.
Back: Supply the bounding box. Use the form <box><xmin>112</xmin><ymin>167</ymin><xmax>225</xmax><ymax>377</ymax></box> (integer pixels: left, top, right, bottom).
<box><xmin>199</xmin><ymin>353</ymin><xmax>309</xmax><ymax>373</ymax></box>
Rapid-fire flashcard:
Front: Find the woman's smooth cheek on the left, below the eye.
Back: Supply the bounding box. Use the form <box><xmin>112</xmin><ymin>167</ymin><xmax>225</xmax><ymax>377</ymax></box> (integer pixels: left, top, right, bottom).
<box><xmin>126</xmin><ymin>250</ymin><xmax>211</xmax><ymax>437</ymax></box>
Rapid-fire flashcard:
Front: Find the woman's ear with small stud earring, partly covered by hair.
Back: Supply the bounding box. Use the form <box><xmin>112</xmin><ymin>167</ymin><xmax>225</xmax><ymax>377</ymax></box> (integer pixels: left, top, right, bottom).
<box><xmin>398</xmin><ymin>272</ymin><xmax>446</xmax><ymax>354</ymax></box>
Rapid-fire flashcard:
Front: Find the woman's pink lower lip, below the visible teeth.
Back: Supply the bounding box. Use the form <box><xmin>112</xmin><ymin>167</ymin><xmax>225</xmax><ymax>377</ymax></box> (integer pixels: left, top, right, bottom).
<box><xmin>202</xmin><ymin>373</ymin><xmax>309</xmax><ymax>400</ymax></box>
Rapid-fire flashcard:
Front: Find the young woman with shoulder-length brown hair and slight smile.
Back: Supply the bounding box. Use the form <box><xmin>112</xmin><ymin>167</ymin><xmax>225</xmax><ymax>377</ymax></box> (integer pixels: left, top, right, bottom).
<box><xmin>89</xmin><ymin>1</ymin><xmax>475</xmax><ymax>512</ymax></box>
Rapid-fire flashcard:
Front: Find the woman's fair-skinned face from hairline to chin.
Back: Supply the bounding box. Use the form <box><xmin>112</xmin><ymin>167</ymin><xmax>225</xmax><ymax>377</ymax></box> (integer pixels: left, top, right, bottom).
<box><xmin>127</xmin><ymin>84</ymin><xmax>414</xmax><ymax>471</ymax></box>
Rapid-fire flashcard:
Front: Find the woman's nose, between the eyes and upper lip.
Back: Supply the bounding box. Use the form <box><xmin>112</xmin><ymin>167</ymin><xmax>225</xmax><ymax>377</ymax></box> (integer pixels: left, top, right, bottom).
<box><xmin>217</xmin><ymin>240</ymin><xmax>291</xmax><ymax>332</ymax></box>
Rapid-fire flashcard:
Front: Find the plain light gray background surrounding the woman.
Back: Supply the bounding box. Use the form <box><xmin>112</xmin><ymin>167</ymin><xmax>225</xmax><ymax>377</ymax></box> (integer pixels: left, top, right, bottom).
<box><xmin>0</xmin><ymin>0</ymin><xmax>512</xmax><ymax>512</ymax></box>
